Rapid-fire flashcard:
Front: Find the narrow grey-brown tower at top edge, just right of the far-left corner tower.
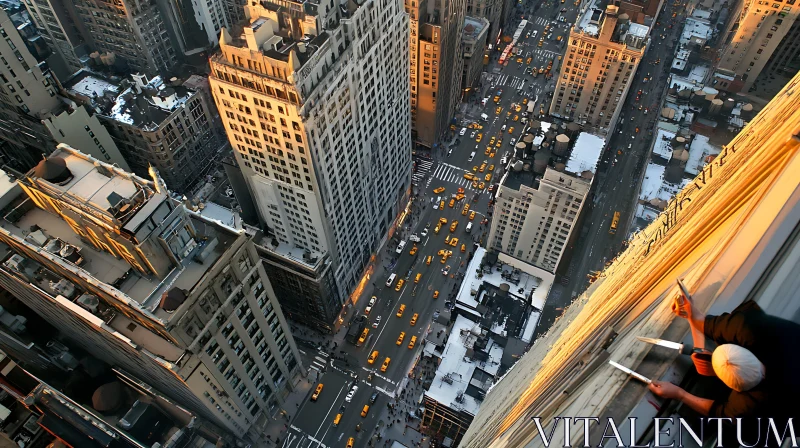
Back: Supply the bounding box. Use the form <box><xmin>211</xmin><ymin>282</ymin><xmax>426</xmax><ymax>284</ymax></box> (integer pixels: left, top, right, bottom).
<box><xmin>23</xmin><ymin>0</ymin><xmax>91</xmax><ymax>73</ymax></box>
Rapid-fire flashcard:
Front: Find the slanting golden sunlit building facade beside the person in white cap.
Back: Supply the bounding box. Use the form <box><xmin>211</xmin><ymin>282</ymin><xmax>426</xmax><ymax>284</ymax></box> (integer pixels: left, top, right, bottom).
<box><xmin>460</xmin><ymin>70</ymin><xmax>800</xmax><ymax>448</ymax></box>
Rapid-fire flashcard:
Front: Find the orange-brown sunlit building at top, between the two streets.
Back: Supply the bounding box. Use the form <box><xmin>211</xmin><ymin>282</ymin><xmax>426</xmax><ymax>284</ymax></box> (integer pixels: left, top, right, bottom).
<box><xmin>550</xmin><ymin>2</ymin><xmax>648</xmax><ymax>135</ymax></box>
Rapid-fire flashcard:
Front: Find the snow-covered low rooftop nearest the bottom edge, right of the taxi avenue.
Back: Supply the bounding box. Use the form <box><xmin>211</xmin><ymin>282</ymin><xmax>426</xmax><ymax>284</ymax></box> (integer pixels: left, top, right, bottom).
<box><xmin>425</xmin><ymin>316</ymin><xmax>503</xmax><ymax>415</ymax></box>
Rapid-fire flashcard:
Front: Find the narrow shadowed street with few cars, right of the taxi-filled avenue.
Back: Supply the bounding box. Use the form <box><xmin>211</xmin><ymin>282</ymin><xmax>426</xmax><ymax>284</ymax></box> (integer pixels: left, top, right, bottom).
<box><xmin>537</xmin><ymin>1</ymin><xmax>685</xmax><ymax>334</ymax></box>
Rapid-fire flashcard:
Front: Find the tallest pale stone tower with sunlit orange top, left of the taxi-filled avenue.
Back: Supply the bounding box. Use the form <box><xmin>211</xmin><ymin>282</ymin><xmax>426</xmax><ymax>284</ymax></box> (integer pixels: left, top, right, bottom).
<box><xmin>210</xmin><ymin>0</ymin><xmax>411</xmax><ymax>314</ymax></box>
